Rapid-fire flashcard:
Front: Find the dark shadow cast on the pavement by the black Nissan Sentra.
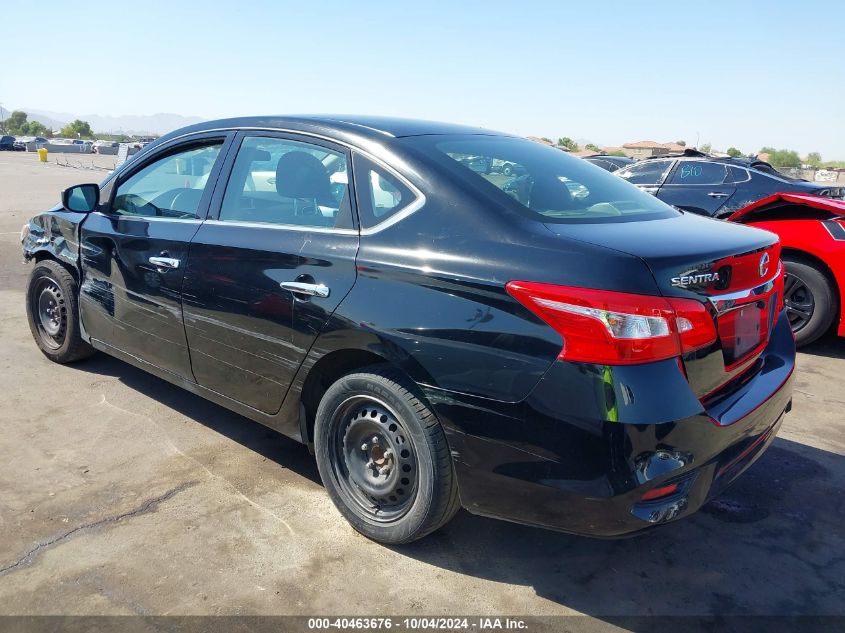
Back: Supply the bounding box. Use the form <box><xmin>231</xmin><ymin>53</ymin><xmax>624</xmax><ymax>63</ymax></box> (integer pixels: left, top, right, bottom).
<box><xmin>76</xmin><ymin>354</ymin><xmax>845</xmax><ymax>616</ymax></box>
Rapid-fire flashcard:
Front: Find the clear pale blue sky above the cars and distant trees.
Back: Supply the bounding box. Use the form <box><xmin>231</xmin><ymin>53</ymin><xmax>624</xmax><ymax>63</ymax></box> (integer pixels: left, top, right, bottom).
<box><xmin>0</xmin><ymin>0</ymin><xmax>845</xmax><ymax>159</ymax></box>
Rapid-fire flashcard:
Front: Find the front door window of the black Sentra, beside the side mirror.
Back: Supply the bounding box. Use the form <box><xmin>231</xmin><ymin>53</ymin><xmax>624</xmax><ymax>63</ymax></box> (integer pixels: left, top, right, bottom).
<box><xmin>111</xmin><ymin>140</ymin><xmax>223</xmax><ymax>218</ymax></box>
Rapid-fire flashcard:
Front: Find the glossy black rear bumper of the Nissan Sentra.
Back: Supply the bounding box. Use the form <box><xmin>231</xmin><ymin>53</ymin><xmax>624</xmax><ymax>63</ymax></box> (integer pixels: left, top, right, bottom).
<box><xmin>428</xmin><ymin>308</ymin><xmax>795</xmax><ymax>537</ymax></box>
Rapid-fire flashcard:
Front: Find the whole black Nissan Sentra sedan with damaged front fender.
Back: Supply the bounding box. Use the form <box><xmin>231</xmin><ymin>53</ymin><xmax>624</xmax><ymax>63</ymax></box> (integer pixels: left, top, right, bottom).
<box><xmin>22</xmin><ymin>117</ymin><xmax>795</xmax><ymax>543</ymax></box>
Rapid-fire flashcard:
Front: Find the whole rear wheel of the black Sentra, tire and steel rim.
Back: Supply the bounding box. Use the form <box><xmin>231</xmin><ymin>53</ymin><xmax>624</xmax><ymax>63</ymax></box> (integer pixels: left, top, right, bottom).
<box><xmin>314</xmin><ymin>366</ymin><xmax>460</xmax><ymax>545</ymax></box>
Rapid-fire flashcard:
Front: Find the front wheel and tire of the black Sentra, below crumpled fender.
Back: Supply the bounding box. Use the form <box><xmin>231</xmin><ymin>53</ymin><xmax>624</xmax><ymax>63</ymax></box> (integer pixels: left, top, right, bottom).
<box><xmin>26</xmin><ymin>259</ymin><xmax>94</xmax><ymax>363</ymax></box>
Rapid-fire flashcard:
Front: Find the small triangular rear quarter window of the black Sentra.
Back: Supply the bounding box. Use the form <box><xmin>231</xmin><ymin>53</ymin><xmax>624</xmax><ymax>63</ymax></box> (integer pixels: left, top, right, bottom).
<box><xmin>352</xmin><ymin>154</ymin><xmax>418</xmax><ymax>229</ymax></box>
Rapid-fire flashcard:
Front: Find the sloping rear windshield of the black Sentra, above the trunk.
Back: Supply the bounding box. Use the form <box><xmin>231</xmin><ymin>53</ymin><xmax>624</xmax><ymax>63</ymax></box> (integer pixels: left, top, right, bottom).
<box><xmin>405</xmin><ymin>135</ymin><xmax>678</xmax><ymax>223</ymax></box>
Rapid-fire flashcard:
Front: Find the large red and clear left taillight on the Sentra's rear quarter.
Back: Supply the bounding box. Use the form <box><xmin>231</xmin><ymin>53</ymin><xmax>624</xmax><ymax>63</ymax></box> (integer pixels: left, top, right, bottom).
<box><xmin>506</xmin><ymin>281</ymin><xmax>716</xmax><ymax>365</ymax></box>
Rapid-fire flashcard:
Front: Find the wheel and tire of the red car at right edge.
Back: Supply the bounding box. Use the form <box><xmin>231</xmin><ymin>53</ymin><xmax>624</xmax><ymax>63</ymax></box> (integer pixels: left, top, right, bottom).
<box><xmin>783</xmin><ymin>256</ymin><xmax>836</xmax><ymax>347</ymax></box>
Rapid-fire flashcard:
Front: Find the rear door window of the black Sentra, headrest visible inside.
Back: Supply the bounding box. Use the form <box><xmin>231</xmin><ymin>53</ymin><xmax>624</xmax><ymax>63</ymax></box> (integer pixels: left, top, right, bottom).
<box><xmin>220</xmin><ymin>136</ymin><xmax>354</xmax><ymax>229</ymax></box>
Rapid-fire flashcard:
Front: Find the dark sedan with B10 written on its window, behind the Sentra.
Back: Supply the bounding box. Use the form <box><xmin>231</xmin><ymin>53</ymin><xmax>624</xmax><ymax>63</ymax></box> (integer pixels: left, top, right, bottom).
<box><xmin>616</xmin><ymin>150</ymin><xmax>845</xmax><ymax>218</ymax></box>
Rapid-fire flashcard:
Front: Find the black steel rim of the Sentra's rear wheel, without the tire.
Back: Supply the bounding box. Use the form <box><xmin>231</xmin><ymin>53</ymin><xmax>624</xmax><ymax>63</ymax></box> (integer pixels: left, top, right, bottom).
<box><xmin>330</xmin><ymin>396</ymin><xmax>418</xmax><ymax>523</ymax></box>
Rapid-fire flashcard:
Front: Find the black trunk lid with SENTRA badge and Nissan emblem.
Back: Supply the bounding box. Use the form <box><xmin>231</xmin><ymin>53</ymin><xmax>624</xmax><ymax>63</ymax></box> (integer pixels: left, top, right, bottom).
<box><xmin>547</xmin><ymin>214</ymin><xmax>783</xmax><ymax>400</ymax></box>
